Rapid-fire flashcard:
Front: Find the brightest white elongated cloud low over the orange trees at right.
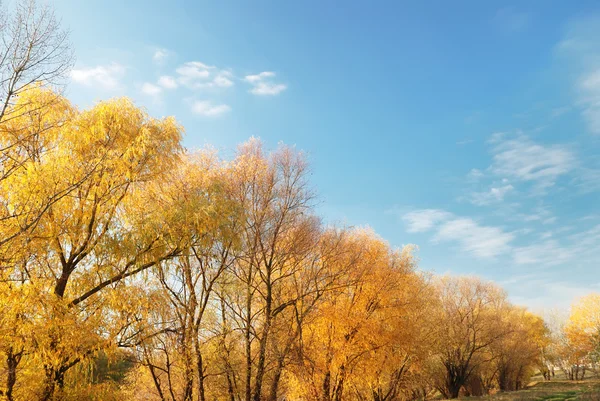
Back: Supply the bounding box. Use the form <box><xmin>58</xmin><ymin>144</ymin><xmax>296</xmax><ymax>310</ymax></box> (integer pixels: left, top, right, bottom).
<box><xmin>434</xmin><ymin>218</ymin><xmax>514</xmax><ymax>259</ymax></box>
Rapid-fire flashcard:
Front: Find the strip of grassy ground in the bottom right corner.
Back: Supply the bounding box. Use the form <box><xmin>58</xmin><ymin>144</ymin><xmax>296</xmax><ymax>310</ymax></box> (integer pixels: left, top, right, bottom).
<box><xmin>454</xmin><ymin>380</ymin><xmax>600</xmax><ymax>401</ymax></box>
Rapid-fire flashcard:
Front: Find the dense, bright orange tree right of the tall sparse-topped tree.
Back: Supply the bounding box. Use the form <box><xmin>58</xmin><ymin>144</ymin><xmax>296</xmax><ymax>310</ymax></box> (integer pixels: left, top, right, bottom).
<box><xmin>292</xmin><ymin>230</ymin><xmax>427</xmax><ymax>401</ymax></box>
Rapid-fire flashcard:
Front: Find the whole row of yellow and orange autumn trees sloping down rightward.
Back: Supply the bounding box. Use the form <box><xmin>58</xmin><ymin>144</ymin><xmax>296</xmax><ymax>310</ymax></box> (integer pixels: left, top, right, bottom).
<box><xmin>0</xmin><ymin>87</ymin><xmax>547</xmax><ymax>401</ymax></box>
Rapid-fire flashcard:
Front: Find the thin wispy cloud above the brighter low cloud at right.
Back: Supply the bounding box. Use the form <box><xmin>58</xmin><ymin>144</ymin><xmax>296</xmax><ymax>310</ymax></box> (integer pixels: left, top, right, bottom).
<box><xmin>490</xmin><ymin>134</ymin><xmax>576</xmax><ymax>188</ymax></box>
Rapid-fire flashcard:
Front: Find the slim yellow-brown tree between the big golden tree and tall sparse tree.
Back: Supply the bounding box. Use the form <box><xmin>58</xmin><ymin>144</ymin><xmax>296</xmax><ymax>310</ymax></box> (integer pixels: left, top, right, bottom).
<box><xmin>126</xmin><ymin>151</ymin><xmax>242</xmax><ymax>400</ymax></box>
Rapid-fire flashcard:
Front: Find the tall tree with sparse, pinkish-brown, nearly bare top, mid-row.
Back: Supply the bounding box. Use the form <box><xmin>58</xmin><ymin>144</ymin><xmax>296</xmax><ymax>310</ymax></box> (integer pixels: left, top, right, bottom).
<box><xmin>221</xmin><ymin>139</ymin><xmax>322</xmax><ymax>401</ymax></box>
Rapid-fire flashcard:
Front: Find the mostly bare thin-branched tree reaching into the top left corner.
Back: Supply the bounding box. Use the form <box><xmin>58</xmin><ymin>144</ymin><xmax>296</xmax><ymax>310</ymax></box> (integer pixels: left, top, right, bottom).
<box><xmin>0</xmin><ymin>0</ymin><xmax>73</xmax><ymax>252</ymax></box>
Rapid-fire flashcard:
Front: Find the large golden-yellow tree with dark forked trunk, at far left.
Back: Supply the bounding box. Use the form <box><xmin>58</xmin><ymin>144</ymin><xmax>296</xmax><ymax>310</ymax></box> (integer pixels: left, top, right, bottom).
<box><xmin>0</xmin><ymin>89</ymin><xmax>181</xmax><ymax>400</ymax></box>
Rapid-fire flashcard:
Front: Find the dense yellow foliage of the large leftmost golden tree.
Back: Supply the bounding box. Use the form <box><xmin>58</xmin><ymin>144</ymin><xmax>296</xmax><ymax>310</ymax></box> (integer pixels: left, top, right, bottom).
<box><xmin>0</xmin><ymin>87</ymin><xmax>189</xmax><ymax>400</ymax></box>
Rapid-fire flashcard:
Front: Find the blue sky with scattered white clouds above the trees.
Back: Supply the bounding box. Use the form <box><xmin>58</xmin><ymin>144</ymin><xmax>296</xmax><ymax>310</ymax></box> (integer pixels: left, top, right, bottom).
<box><xmin>53</xmin><ymin>0</ymin><xmax>600</xmax><ymax>311</ymax></box>
